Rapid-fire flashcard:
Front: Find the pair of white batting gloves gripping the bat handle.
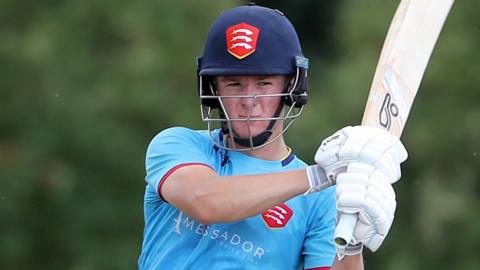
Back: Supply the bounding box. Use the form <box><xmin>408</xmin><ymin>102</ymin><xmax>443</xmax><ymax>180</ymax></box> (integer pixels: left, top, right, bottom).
<box><xmin>306</xmin><ymin>126</ymin><xmax>408</xmax><ymax>255</ymax></box>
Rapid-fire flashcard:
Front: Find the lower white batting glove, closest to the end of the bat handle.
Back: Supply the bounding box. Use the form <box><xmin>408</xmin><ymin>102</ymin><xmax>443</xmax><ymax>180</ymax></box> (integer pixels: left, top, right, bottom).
<box><xmin>336</xmin><ymin>163</ymin><xmax>396</xmax><ymax>255</ymax></box>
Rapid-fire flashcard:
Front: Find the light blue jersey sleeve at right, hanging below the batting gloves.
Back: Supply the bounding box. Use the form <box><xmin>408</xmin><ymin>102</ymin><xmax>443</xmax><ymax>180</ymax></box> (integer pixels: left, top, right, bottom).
<box><xmin>302</xmin><ymin>187</ymin><xmax>337</xmax><ymax>269</ymax></box>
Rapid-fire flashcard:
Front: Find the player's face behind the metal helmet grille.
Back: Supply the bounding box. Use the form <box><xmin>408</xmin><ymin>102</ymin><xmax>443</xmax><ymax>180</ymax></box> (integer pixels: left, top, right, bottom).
<box><xmin>216</xmin><ymin>75</ymin><xmax>286</xmax><ymax>138</ymax></box>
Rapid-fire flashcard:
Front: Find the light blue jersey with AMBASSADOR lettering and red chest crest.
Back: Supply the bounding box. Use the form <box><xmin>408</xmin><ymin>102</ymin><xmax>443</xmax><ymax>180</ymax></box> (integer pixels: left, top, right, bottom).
<box><xmin>138</xmin><ymin>128</ymin><xmax>336</xmax><ymax>269</ymax></box>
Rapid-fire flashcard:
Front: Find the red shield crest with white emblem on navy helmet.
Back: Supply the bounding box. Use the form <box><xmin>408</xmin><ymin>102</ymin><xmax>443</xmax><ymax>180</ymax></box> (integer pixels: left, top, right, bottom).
<box><xmin>226</xmin><ymin>23</ymin><xmax>260</xmax><ymax>59</ymax></box>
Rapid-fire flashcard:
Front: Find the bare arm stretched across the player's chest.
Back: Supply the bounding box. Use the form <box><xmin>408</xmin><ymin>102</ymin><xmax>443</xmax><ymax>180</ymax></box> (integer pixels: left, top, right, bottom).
<box><xmin>161</xmin><ymin>165</ymin><xmax>309</xmax><ymax>224</ymax></box>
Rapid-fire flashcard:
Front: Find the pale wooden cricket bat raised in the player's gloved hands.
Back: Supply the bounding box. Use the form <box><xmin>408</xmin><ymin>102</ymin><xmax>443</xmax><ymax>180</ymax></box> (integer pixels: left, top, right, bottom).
<box><xmin>334</xmin><ymin>0</ymin><xmax>454</xmax><ymax>253</ymax></box>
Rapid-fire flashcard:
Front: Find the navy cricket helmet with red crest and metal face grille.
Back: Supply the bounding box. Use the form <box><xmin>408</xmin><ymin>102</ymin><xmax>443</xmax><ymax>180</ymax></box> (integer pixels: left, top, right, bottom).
<box><xmin>197</xmin><ymin>5</ymin><xmax>308</xmax><ymax>150</ymax></box>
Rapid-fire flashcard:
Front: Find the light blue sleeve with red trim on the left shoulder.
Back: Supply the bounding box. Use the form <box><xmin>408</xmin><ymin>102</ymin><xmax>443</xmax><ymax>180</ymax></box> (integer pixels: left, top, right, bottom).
<box><xmin>145</xmin><ymin>127</ymin><xmax>214</xmax><ymax>199</ymax></box>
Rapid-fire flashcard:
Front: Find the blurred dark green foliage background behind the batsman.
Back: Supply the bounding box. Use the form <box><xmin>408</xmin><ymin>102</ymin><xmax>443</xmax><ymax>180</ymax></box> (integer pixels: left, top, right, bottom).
<box><xmin>0</xmin><ymin>0</ymin><xmax>480</xmax><ymax>270</ymax></box>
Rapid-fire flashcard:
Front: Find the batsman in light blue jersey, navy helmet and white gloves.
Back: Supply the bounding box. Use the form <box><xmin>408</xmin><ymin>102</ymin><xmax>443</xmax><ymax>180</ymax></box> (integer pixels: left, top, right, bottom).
<box><xmin>138</xmin><ymin>4</ymin><xmax>407</xmax><ymax>270</ymax></box>
